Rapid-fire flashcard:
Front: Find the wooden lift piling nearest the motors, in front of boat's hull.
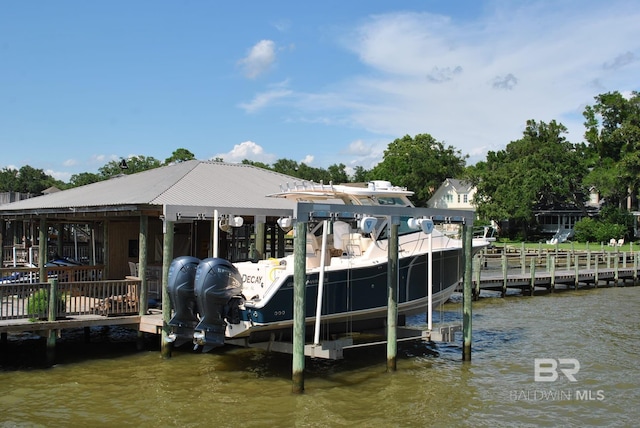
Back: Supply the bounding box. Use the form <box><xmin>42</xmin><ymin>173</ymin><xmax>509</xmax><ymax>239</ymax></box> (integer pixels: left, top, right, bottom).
<box><xmin>291</xmin><ymin>219</ymin><xmax>307</xmax><ymax>394</ymax></box>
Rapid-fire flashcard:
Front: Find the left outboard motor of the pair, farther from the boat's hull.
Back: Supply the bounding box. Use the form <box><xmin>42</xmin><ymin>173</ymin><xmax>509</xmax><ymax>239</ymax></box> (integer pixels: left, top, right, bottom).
<box><xmin>167</xmin><ymin>256</ymin><xmax>200</xmax><ymax>346</ymax></box>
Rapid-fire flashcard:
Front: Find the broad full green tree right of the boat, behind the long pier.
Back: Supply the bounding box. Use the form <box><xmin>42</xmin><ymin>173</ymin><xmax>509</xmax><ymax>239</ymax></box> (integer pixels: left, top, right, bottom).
<box><xmin>468</xmin><ymin>120</ymin><xmax>587</xmax><ymax>237</ymax></box>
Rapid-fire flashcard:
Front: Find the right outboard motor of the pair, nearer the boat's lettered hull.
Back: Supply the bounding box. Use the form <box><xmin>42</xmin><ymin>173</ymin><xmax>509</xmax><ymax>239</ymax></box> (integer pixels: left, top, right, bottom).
<box><xmin>193</xmin><ymin>258</ymin><xmax>242</xmax><ymax>352</ymax></box>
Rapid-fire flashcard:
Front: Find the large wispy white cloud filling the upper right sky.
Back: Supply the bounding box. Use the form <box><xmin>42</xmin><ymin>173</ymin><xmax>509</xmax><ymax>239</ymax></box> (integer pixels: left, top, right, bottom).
<box><xmin>251</xmin><ymin>1</ymin><xmax>640</xmax><ymax>163</ymax></box>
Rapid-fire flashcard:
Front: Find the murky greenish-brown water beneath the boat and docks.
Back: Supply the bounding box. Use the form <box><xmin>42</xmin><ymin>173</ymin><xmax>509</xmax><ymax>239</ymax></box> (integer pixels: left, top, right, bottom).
<box><xmin>0</xmin><ymin>287</ymin><xmax>640</xmax><ymax>427</ymax></box>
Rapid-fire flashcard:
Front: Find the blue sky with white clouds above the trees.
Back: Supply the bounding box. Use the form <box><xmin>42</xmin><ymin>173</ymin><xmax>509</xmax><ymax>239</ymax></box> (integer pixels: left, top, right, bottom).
<box><xmin>0</xmin><ymin>0</ymin><xmax>640</xmax><ymax>181</ymax></box>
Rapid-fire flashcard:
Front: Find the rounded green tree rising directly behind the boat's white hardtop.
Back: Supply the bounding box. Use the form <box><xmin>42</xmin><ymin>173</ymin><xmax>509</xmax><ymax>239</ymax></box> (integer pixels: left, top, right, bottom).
<box><xmin>368</xmin><ymin>134</ymin><xmax>467</xmax><ymax>207</ymax></box>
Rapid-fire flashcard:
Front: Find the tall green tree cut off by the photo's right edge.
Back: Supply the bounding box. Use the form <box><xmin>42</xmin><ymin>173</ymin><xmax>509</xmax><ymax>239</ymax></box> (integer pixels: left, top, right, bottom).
<box><xmin>583</xmin><ymin>91</ymin><xmax>640</xmax><ymax>208</ymax></box>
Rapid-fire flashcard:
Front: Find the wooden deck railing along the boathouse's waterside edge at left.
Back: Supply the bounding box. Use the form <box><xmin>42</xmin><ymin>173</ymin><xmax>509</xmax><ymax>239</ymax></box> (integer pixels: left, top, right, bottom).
<box><xmin>0</xmin><ymin>279</ymin><xmax>141</xmax><ymax>321</ymax></box>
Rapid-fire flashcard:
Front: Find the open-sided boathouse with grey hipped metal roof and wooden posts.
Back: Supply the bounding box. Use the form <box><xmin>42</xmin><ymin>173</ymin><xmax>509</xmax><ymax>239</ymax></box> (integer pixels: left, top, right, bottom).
<box><xmin>0</xmin><ymin>160</ymin><xmax>296</xmax><ymax>330</ymax></box>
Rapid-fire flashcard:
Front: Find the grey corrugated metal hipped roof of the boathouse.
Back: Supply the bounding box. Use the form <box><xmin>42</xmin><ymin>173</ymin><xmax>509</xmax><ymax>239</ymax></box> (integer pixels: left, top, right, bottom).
<box><xmin>0</xmin><ymin>160</ymin><xmax>296</xmax><ymax>214</ymax></box>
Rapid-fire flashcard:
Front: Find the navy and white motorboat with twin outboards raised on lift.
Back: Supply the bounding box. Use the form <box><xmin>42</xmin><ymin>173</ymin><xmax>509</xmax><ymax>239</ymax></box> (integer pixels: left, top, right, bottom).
<box><xmin>168</xmin><ymin>181</ymin><xmax>489</xmax><ymax>352</ymax></box>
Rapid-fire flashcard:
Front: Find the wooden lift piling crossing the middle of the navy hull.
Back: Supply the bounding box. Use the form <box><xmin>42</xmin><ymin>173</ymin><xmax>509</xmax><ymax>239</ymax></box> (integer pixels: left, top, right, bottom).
<box><xmin>387</xmin><ymin>216</ymin><xmax>398</xmax><ymax>372</ymax></box>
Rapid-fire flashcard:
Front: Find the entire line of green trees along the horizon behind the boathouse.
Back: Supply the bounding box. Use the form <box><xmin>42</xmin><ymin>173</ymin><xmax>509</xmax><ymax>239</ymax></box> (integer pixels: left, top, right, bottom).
<box><xmin>0</xmin><ymin>91</ymin><xmax>640</xmax><ymax>238</ymax></box>
